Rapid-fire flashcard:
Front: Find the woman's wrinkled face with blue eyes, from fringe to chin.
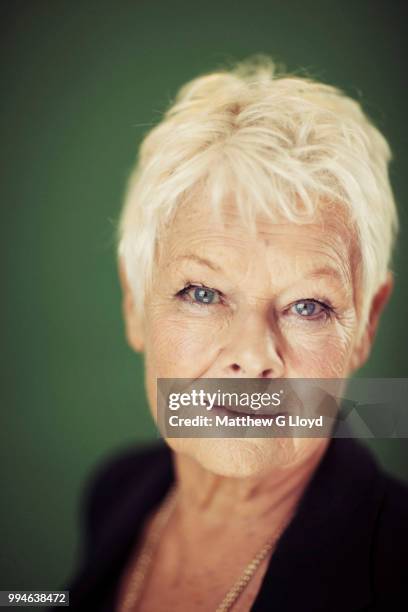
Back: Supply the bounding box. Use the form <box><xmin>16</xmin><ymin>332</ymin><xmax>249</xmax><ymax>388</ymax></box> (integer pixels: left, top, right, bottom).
<box><xmin>122</xmin><ymin>200</ymin><xmax>376</xmax><ymax>476</ymax></box>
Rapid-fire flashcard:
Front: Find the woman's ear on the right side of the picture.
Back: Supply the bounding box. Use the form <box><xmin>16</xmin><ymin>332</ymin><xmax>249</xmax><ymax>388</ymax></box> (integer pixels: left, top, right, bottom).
<box><xmin>351</xmin><ymin>271</ymin><xmax>394</xmax><ymax>371</ymax></box>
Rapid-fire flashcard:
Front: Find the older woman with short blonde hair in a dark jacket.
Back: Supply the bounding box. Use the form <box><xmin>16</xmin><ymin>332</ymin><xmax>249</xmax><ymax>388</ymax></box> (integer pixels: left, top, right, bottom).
<box><xmin>63</xmin><ymin>56</ymin><xmax>408</xmax><ymax>612</ymax></box>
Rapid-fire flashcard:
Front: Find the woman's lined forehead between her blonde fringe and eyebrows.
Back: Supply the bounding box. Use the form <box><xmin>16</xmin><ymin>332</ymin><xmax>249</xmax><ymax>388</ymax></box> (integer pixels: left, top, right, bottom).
<box><xmin>162</xmin><ymin>197</ymin><xmax>356</xmax><ymax>265</ymax></box>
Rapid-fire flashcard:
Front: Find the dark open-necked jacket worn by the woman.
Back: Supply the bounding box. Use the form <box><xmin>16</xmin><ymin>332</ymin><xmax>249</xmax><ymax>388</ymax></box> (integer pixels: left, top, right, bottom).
<box><xmin>62</xmin><ymin>438</ymin><xmax>408</xmax><ymax>612</ymax></box>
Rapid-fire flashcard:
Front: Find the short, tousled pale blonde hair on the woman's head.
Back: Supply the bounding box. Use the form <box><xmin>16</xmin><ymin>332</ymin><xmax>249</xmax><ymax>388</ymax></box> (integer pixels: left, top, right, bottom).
<box><xmin>117</xmin><ymin>55</ymin><xmax>398</xmax><ymax>340</ymax></box>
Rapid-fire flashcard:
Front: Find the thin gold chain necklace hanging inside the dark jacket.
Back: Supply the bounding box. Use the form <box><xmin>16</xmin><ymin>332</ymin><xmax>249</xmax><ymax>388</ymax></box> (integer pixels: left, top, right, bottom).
<box><xmin>120</xmin><ymin>488</ymin><xmax>291</xmax><ymax>612</ymax></box>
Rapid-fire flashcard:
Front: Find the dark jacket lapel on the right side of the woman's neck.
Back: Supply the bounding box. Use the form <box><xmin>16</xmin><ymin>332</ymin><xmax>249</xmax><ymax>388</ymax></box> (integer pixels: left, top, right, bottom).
<box><xmin>253</xmin><ymin>438</ymin><xmax>384</xmax><ymax>612</ymax></box>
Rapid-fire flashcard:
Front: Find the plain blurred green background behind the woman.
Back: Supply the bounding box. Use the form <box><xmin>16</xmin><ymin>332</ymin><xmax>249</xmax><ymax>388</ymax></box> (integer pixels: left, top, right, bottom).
<box><xmin>0</xmin><ymin>0</ymin><xmax>408</xmax><ymax>589</ymax></box>
